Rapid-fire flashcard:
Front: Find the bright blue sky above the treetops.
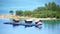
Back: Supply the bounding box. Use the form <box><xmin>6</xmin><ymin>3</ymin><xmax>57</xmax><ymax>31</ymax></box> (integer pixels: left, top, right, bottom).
<box><xmin>0</xmin><ymin>0</ymin><xmax>60</xmax><ymax>13</ymax></box>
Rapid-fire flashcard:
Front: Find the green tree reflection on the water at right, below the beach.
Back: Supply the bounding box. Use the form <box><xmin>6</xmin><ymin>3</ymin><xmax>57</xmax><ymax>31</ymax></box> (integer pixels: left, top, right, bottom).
<box><xmin>43</xmin><ymin>20</ymin><xmax>60</xmax><ymax>30</ymax></box>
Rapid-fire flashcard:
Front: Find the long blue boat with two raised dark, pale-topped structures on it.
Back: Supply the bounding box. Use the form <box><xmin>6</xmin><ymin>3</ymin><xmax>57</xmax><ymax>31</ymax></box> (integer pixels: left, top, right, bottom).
<box><xmin>4</xmin><ymin>19</ymin><xmax>42</xmax><ymax>28</ymax></box>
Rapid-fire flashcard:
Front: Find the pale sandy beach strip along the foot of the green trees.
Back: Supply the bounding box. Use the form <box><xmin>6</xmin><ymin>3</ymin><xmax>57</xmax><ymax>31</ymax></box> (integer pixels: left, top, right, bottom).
<box><xmin>0</xmin><ymin>14</ymin><xmax>59</xmax><ymax>20</ymax></box>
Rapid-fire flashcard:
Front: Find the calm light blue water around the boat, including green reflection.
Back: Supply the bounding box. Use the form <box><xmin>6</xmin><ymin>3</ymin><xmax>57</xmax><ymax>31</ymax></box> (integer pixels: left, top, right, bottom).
<box><xmin>0</xmin><ymin>19</ymin><xmax>60</xmax><ymax>34</ymax></box>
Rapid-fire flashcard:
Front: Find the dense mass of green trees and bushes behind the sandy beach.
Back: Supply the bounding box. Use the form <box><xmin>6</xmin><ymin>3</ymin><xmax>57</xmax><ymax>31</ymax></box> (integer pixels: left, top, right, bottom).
<box><xmin>10</xmin><ymin>2</ymin><xmax>60</xmax><ymax>18</ymax></box>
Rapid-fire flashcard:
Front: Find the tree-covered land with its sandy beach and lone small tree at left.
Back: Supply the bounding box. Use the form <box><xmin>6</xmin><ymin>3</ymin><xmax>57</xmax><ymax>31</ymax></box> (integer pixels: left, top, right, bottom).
<box><xmin>0</xmin><ymin>2</ymin><xmax>60</xmax><ymax>20</ymax></box>
